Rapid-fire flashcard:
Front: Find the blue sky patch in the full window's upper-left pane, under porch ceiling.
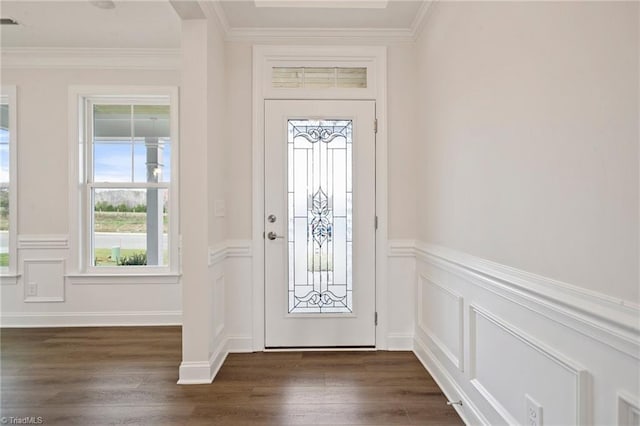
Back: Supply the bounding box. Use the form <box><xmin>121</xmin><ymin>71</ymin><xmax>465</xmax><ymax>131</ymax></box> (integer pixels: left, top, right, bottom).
<box><xmin>93</xmin><ymin>141</ymin><xmax>132</xmax><ymax>182</ymax></box>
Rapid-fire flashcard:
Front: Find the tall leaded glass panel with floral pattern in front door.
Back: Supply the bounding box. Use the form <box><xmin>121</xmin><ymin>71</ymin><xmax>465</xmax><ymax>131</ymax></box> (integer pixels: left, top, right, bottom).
<box><xmin>287</xmin><ymin>120</ymin><xmax>353</xmax><ymax>314</ymax></box>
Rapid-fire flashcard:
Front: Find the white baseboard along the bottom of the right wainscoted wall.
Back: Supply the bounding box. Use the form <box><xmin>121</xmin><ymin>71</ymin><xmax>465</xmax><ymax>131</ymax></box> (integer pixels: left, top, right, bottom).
<box><xmin>413</xmin><ymin>338</ymin><xmax>490</xmax><ymax>426</ymax></box>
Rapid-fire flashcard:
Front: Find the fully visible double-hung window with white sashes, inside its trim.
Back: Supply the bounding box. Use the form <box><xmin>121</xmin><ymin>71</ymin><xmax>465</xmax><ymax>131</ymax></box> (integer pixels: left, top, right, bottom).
<box><xmin>79</xmin><ymin>90</ymin><xmax>177</xmax><ymax>273</ymax></box>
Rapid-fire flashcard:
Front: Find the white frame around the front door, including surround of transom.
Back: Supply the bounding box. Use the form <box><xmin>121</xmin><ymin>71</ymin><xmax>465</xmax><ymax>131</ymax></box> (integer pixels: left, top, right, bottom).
<box><xmin>251</xmin><ymin>45</ymin><xmax>389</xmax><ymax>351</ymax></box>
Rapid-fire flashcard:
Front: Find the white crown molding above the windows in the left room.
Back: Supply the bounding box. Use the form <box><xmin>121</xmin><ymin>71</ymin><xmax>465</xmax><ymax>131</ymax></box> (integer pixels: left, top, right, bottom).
<box><xmin>1</xmin><ymin>47</ymin><xmax>181</xmax><ymax>70</ymax></box>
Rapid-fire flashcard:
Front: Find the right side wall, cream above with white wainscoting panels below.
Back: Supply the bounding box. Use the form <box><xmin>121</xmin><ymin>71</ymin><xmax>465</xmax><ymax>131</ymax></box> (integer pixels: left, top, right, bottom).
<box><xmin>410</xmin><ymin>2</ymin><xmax>640</xmax><ymax>425</ymax></box>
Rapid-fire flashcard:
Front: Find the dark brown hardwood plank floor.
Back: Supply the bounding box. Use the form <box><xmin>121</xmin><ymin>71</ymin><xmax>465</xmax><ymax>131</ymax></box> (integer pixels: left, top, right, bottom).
<box><xmin>0</xmin><ymin>327</ymin><xmax>462</xmax><ymax>425</ymax></box>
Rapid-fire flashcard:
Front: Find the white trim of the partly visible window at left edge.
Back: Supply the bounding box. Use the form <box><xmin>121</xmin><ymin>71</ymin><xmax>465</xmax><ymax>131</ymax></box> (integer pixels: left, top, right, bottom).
<box><xmin>0</xmin><ymin>86</ymin><xmax>20</xmax><ymax>284</ymax></box>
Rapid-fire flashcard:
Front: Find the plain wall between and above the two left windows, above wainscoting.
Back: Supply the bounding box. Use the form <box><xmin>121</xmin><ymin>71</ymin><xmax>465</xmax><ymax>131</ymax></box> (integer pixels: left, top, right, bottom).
<box><xmin>2</xmin><ymin>68</ymin><xmax>180</xmax><ymax>235</ymax></box>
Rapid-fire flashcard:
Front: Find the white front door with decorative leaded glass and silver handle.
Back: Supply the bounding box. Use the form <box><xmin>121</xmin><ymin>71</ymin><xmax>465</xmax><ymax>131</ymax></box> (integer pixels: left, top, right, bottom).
<box><xmin>264</xmin><ymin>100</ymin><xmax>375</xmax><ymax>348</ymax></box>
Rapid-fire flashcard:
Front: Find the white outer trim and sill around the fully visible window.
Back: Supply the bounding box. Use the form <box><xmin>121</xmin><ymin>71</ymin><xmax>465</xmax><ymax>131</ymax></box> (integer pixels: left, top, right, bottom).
<box><xmin>68</xmin><ymin>86</ymin><xmax>180</xmax><ymax>284</ymax></box>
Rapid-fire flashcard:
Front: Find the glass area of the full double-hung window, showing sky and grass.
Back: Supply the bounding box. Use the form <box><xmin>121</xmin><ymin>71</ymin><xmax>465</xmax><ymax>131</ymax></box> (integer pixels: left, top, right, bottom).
<box><xmin>87</xmin><ymin>103</ymin><xmax>172</xmax><ymax>267</ymax></box>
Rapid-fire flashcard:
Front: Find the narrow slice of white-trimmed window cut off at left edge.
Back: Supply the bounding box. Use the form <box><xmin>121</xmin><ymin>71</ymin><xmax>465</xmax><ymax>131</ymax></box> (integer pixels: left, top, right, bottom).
<box><xmin>0</xmin><ymin>86</ymin><xmax>18</xmax><ymax>276</ymax></box>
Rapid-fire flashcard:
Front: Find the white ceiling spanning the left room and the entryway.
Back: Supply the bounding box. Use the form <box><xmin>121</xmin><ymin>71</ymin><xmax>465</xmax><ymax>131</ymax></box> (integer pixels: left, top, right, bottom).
<box><xmin>0</xmin><ymin>0</ymin><xmax>425</xmax><ymax>48</ymax></box>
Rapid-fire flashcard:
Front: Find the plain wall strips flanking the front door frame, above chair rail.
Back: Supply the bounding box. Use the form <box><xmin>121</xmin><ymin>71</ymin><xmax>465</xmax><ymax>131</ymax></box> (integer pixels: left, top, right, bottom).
<box><xmin>225</xmin><ymin>40</ymin><xmax>417</xmax><ymax>243</ymax></box>
